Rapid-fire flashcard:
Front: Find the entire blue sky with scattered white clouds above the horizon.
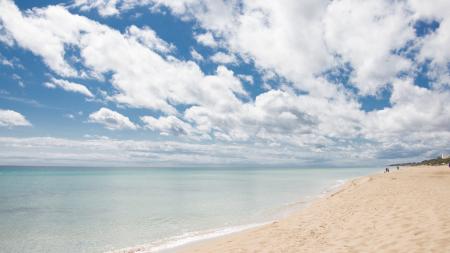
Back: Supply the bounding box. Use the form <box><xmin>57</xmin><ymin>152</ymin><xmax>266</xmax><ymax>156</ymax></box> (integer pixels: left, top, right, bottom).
<box><xmin>0</xmin><ymin>0</ymin><xmax>450</xmax><ymax>167</ymax></box>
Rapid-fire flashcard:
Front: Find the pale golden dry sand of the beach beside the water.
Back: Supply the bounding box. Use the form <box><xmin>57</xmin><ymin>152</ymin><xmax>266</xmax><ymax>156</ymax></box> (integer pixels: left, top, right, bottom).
<box><xmin>179</xmin><ymin>166</ymin><xmax>450</xmax><ymax>253</ymax></box>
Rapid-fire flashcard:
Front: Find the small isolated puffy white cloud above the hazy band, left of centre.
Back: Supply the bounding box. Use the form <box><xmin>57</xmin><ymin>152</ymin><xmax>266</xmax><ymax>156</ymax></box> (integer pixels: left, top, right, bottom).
<box><xmin>89</xmin><ymin>107</ymin><xmax>138</xmax><ymax>130</ymax></box>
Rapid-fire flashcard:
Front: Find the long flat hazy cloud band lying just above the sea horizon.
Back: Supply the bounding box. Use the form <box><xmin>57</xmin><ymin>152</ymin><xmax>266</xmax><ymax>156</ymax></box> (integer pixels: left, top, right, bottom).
<box><xmin>0</xmin><ymin>135</ymin><xmax>384</xmax><ymax>167</ymax></box>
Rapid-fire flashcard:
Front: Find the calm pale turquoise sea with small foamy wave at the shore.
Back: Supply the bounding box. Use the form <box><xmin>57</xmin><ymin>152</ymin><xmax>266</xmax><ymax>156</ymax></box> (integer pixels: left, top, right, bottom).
<box><xmin>0</xmin><ymin>167</ymin><xmax>374</xmax><ymax>253</ymax></box>
